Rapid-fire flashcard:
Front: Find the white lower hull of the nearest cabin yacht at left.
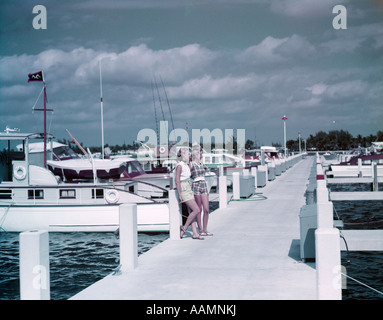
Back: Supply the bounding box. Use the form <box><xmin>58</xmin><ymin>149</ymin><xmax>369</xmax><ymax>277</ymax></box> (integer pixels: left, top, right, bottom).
<box><xmin>0</xmin><ymin>203</ymin><xmax>169</xmax><ymax>232</ymax></box>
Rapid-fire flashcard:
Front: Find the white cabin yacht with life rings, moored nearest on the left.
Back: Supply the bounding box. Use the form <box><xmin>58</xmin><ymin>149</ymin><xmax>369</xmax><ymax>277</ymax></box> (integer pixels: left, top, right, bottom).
<box><xmin>0</xmin><ymin>131</ymin><xmax>169</xmax><ymax>232</ymax></box>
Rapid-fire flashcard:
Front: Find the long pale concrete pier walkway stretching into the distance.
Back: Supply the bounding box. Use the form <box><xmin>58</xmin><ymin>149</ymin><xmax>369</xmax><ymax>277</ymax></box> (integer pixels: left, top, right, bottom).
<box><xmin>71</xmin><ymin>157</ymin><xmax>317</xmax><ymax>300</ymax></box>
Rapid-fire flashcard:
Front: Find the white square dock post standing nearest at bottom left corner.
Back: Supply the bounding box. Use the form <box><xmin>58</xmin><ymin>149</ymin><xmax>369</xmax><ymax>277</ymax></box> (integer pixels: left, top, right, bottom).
<box><xmin>20</xmin><ymin>230</ymin><xmax>50</xmax><ymax>300</ymax></box>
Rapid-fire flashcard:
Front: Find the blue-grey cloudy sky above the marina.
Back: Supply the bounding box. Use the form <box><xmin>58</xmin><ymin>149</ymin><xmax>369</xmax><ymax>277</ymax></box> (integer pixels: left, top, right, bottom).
<box><xmin>0</xmin><ymin>0</ymin><xmax>383</xmax><ymax>146</ymax></box>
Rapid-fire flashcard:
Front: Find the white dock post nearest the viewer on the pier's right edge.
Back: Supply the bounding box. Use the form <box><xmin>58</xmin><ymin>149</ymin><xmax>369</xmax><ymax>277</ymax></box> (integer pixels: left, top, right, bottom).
<box><xmin>315</xmin><ymin>228</ymin><xmax>342</xmax><ymax>300</ymax></box>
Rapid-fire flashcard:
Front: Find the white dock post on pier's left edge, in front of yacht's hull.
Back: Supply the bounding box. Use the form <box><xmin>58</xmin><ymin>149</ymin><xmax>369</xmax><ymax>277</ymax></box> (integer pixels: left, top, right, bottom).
<box><xmin>120</xmin><ymin>203</ymin><xmax>138</xmax><ymax>272</ymax></box>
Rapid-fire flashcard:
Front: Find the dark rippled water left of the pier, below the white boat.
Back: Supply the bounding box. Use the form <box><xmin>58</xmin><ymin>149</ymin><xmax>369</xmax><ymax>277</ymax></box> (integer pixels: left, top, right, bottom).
<box><xmin>0</xmin><ymin>232</ymin><xmax>169</xmax><ymax>300</ymax></box>
